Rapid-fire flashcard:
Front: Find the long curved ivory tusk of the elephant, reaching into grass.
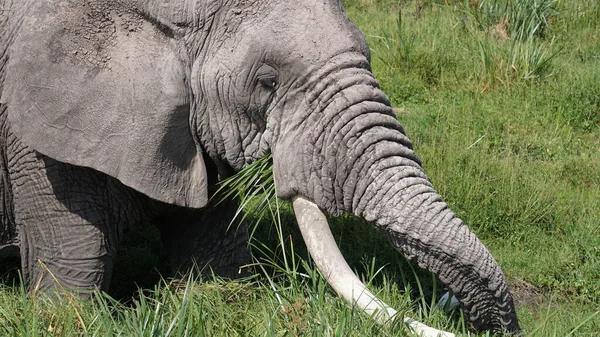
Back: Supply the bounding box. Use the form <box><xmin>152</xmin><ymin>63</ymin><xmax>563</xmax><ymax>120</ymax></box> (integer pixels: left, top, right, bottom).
<box><xmin>292</xmin><ymin>197</ymin><xmax>454</xmax><ymax>337</ymax></box>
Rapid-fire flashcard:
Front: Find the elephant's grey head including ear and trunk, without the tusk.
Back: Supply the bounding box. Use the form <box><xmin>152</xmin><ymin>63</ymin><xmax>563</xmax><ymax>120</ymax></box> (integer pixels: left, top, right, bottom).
<box><xmin>0</xmin><ymin>0</ymin><xmax>520</xmax><ymax>333</ymax></box>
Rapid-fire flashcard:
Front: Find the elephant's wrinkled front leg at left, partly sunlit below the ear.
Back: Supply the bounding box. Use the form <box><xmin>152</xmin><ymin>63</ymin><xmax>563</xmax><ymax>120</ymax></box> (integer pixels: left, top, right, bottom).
<box><xmin>11</xmin><ymin>147</ymin><xmax>150</xmax><ymax>296</ymax></box>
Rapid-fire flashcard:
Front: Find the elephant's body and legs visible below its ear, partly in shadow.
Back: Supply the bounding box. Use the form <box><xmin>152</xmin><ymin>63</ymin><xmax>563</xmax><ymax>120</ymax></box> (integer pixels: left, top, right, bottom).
<box><xmin>0</xmin><ymin>102</ymin><xmax>250</xmax><ymax>290</ymax></box>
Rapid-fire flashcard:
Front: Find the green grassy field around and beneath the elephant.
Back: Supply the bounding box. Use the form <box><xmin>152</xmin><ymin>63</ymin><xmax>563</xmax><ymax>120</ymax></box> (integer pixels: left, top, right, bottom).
<box><xmin>0</xmin><ymin>0</ymin><xmax>600</xmax><ymax>336</ymax></box>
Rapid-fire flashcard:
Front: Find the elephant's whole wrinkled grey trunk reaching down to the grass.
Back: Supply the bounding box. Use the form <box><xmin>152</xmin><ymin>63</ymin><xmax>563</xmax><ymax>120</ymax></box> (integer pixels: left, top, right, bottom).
<box><xmin>274</xmin><ymin>55</ymin><xmax>520</xmax><ymax>334</ymax></box>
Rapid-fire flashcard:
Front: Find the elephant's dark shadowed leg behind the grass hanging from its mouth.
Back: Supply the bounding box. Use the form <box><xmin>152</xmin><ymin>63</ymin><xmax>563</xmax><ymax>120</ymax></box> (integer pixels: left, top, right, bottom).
<box><xmin>158</xmin><ymin>202</ymin><xmax>251</xmax><ymax>278</ymax></box>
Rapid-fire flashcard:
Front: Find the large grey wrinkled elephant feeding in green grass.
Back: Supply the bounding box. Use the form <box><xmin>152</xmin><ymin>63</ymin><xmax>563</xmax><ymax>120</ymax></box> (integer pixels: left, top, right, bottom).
<box><xmin>0</xmin><ymin>0</ymin><xmax>520</xmax><ymax>334</ymax></box>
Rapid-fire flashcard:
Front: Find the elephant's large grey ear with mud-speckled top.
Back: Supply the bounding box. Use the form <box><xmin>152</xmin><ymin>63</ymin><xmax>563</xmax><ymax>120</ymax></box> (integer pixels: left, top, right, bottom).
<box><xmin>1</xmin><ymin>1</ymin><xmax>208</xmax><ymax>208</ymax></box>
